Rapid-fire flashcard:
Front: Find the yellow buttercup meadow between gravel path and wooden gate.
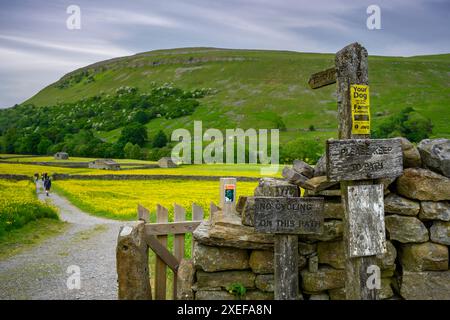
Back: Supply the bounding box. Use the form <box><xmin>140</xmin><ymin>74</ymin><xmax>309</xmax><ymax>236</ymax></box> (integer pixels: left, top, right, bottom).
<box><xmin>53</xmin><ymin>180</ymin><xmax>257</xmax><ymax>222</ymax></box>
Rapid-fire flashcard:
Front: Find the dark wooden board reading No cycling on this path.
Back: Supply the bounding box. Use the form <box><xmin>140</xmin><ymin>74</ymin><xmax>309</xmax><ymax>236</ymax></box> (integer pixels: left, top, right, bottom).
<box><xmin>255</xmin><ymin>197</ymin><xmax>324</xmax><ymax>234</ymax></box>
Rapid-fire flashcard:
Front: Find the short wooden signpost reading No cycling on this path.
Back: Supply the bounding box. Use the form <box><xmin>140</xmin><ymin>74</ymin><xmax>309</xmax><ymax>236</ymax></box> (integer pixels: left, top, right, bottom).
<box><xmin>254</xmin><ymin>197</ymin><xmax>324</xmax><ymax>300</ymax></box>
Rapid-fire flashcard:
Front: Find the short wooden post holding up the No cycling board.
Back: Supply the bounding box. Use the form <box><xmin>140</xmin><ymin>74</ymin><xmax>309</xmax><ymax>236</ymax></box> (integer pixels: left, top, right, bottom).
<box><xmin>274</xmin><ymin>234</ymin><xmax>299</xmax><ymax>300</ymax></box>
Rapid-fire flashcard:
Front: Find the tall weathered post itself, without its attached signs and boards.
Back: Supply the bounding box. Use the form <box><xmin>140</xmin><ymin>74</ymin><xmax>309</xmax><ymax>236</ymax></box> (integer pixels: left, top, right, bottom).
<box><xmin>335</xmin><ymin>43</ymin><xmax>378</xmax><ymax>300</ymax></box>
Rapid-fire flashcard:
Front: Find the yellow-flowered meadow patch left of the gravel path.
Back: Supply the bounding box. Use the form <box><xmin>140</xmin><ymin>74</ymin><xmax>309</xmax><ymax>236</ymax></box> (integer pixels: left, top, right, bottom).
<box><xmin>0</xmin><ymin>180</ymin><xmax>58</xmax><ymax>238</ymax></box>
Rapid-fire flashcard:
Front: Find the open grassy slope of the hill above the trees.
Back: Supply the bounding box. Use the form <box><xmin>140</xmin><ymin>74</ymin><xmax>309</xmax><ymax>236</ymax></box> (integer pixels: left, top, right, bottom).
<box><xmin>26</xmin><ymin>48</ymin><xmax>450</xmax><ymax>142</ymax></box>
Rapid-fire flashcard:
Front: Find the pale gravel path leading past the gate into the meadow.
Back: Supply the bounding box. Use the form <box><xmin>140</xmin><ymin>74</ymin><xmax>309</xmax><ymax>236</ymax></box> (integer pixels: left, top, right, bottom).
<box><xmin>0</xmin><ymin>182</ymin><xmax>133</xmax><ymax>300</ymax></box>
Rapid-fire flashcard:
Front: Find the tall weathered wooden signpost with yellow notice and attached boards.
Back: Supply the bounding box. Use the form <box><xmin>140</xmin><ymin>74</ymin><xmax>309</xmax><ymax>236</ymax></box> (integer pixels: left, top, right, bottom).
<box><xmin>310</xmin><ymin>43</ymin><xmax>403</xmax><ymax>300</ymax></box>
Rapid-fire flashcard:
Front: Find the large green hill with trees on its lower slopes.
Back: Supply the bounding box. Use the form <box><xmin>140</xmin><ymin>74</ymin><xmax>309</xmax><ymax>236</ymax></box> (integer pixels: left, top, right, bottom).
<box><xmin>0</xmin><ymin>48</ymin><xmax>450</xmax><ymax>163</ymax></box>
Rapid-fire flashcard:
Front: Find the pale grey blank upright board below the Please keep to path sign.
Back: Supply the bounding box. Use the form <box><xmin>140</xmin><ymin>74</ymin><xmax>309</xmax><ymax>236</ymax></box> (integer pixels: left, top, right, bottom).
<box><xmin>348</xmin><ymin>184</ymin><xmax>386</xmax><ymax>257</ymax></box>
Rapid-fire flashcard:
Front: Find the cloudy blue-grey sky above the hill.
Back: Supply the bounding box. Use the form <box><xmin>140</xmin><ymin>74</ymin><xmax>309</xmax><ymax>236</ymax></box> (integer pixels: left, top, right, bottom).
<box><xmin>0</xmin><ymin>0</ymin><xmax>450</xmax><ymax>108</ymax></box>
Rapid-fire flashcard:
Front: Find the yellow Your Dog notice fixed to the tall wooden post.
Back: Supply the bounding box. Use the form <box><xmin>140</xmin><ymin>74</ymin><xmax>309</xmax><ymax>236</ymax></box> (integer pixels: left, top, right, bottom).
<box><xmin>350</xmin><ymin>84</ymin><xmax>370</xmax><ymax>134</ymax></box>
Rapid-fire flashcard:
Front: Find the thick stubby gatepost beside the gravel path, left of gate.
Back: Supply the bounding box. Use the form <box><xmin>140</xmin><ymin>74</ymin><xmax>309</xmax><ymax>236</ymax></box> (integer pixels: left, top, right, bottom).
<box><xmin>116</xmin><ymin>221</ymin><xmax>152</xmax><ymax>300</ymax></box>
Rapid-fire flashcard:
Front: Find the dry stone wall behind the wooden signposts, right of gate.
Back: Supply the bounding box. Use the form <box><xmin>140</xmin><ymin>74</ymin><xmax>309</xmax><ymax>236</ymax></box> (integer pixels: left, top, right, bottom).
<box><xmin>179</xmin><ymin>139</ymin><xmax>450</xmax><ymax>300</ymax></box>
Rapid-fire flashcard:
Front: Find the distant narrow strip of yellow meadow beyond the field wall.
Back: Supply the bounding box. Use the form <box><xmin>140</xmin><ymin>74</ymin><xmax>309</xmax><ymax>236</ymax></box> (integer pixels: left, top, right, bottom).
<box><xmin>0</xmin><ymin>160</ymin><xmax>283</xmax><ymax>177</ymax></box>
